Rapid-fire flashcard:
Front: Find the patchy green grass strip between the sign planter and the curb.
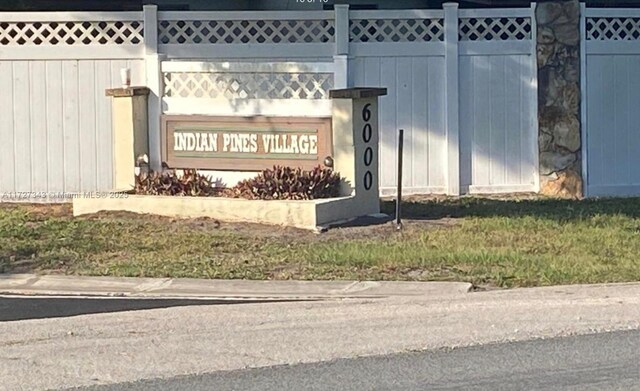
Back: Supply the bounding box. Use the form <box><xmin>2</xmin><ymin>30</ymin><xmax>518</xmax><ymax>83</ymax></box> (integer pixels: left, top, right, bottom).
<box><xmin>0</xmin><ymin>197</ymin><xmax>640</xmax><ymax>287</ymax></box>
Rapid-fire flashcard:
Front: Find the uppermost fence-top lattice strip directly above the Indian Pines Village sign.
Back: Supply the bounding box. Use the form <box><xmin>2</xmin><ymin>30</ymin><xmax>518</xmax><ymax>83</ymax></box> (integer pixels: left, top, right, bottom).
<box><xmin>158</xmin><ymin>20</ymin><xmax>335</xmax><ymax>44</ymax></box>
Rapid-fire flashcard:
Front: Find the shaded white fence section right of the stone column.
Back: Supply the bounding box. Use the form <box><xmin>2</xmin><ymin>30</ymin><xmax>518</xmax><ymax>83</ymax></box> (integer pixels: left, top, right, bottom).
<box><xmin>583</xmin><ymin>8</ymin><xmax>640</xmax><ymax>196</ymax></box>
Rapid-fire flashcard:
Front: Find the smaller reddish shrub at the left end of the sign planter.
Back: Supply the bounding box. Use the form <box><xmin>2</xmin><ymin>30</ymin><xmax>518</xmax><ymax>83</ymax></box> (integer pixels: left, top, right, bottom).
<box><xmin>135</xmin><ymin>170</ymin><xmax>219</xmax><ymax>197</ymax></box>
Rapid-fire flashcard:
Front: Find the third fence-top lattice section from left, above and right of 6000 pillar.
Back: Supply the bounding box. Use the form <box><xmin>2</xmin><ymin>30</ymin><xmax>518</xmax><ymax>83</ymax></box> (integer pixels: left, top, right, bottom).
<box><xmin>349</xmin><ymin>19</ymin><xmax>444</xmax><ymax>42</ymax></box>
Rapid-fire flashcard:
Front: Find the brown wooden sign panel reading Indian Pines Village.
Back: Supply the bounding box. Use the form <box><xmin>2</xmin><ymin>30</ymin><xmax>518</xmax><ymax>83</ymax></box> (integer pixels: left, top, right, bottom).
<box><xmin>162</xmin><ymin>115</ymin><xmax>332</xmax><ymax>171</ymax></box>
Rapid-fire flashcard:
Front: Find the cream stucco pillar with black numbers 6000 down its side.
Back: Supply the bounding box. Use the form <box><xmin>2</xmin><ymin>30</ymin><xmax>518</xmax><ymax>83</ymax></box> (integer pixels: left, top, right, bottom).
<box><xmin>330</xmin><ymin>88</ymin><xmax>387</xmax><ymax>215</ymax></box>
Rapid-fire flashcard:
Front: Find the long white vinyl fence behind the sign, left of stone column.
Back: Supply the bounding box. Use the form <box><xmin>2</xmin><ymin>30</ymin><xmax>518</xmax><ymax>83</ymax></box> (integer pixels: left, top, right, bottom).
<box><xmin>0</xmin><ymin>5</ymin><xmax>538</xmax><ymax>198</ymax></box>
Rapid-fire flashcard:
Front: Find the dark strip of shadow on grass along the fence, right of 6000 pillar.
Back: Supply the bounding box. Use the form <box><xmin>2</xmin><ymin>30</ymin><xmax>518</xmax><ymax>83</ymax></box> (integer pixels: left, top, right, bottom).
<box><xmin>381</xmin><ymin>197</ymin><xmax>640</xmax><ymax>221</ymax></box>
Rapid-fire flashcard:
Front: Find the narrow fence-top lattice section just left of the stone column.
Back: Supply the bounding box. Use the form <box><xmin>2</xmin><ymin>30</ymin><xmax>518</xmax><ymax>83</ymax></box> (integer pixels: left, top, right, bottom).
<box><xmin>458</xmin><ymin>17</ymin><xmax>531</xmax><ymax>41</ymax></box>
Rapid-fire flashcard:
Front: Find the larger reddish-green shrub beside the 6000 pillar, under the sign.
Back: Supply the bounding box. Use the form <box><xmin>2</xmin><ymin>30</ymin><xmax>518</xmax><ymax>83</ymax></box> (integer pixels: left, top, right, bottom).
<box><xmin>224</xmin><ymin>166</ymin><xmax>342</xmax><ymax>200</ymax></box>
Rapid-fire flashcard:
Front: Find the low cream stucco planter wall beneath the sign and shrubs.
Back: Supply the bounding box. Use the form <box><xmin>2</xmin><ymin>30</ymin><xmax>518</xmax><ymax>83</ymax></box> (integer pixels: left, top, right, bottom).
<box><xmin>73</xmin><ymin>195</ymin><xmax>379</xmax><ymax>230</ymax></box>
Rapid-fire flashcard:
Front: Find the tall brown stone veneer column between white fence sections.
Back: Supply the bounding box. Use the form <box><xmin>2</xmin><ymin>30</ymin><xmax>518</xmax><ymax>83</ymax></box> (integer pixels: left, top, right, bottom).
<box><xmin>536</xmin><ymin>0</ymin><xmax>582</xmax><ymax>198</ymax></box>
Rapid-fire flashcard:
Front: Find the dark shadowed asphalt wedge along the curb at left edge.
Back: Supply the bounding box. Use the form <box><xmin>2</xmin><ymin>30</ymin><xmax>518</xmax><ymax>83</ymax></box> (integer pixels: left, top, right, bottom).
<box><xmin>0</xmin><ymin>296</ymin><xmax>292</xmax><ymax>322</ymax></box>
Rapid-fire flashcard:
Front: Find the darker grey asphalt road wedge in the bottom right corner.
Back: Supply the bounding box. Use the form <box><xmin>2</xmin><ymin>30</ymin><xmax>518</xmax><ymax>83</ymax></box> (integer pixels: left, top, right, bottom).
<box><xmin>71</xmin><ymin>331</ymin><xmax>640</xmax><ymax>391</ymax></box>
